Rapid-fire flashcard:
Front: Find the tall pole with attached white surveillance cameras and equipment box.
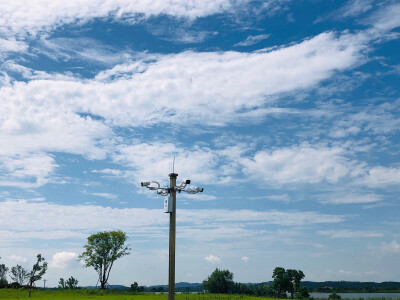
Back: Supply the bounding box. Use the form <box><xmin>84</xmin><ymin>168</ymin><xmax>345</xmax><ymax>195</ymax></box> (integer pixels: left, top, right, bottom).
<box><xmin>141</xmin><ymin>172</ymin><xmax>204</xmax><ymax>300</ymax></box>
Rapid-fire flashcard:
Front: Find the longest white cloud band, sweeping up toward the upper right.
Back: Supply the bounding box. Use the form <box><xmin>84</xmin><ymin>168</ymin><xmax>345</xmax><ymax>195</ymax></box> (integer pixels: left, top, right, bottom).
<box><xmin>2</xmin><ymin>33</ymin><xmax>363</xmax><ymax>126</ymax></box>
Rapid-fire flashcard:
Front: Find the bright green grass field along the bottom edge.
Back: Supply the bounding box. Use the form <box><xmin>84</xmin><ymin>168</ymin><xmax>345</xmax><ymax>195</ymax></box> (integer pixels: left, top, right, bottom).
<box><xmin>0</xmin><ymin>289</ymin><xmax>277</xmax><ymax>300</ymax></box>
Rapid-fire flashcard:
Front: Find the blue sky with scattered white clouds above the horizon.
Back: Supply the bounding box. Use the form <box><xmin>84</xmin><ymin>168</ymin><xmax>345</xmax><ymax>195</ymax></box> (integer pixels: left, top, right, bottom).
<box><xmin>0</xmin><ymin>0</ymin><xmax>400</xmax><ymax>286</ymax></box>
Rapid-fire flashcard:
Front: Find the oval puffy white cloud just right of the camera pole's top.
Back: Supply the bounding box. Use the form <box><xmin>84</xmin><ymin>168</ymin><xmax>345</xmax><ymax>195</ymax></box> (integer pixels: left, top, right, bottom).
<box><xmin>241</xmin><ymin>144</ymin><xmax>353</xmax><ymax>183</ymax></box>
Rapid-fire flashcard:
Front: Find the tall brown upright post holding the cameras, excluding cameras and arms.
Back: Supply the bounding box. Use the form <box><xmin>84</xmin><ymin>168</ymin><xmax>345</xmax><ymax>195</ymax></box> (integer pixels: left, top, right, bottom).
<box><xmin>168</xmin><ymin>173</ymin><xmax>178</xmax><ymax>300</ymax></box>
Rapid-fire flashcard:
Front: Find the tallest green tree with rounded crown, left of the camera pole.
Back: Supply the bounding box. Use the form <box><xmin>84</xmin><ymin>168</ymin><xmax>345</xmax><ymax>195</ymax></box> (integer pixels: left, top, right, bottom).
<box><xmin>79</xmin><ymin>230</ymin><xmax>131</xmax><ymax>289</ymax></box>
